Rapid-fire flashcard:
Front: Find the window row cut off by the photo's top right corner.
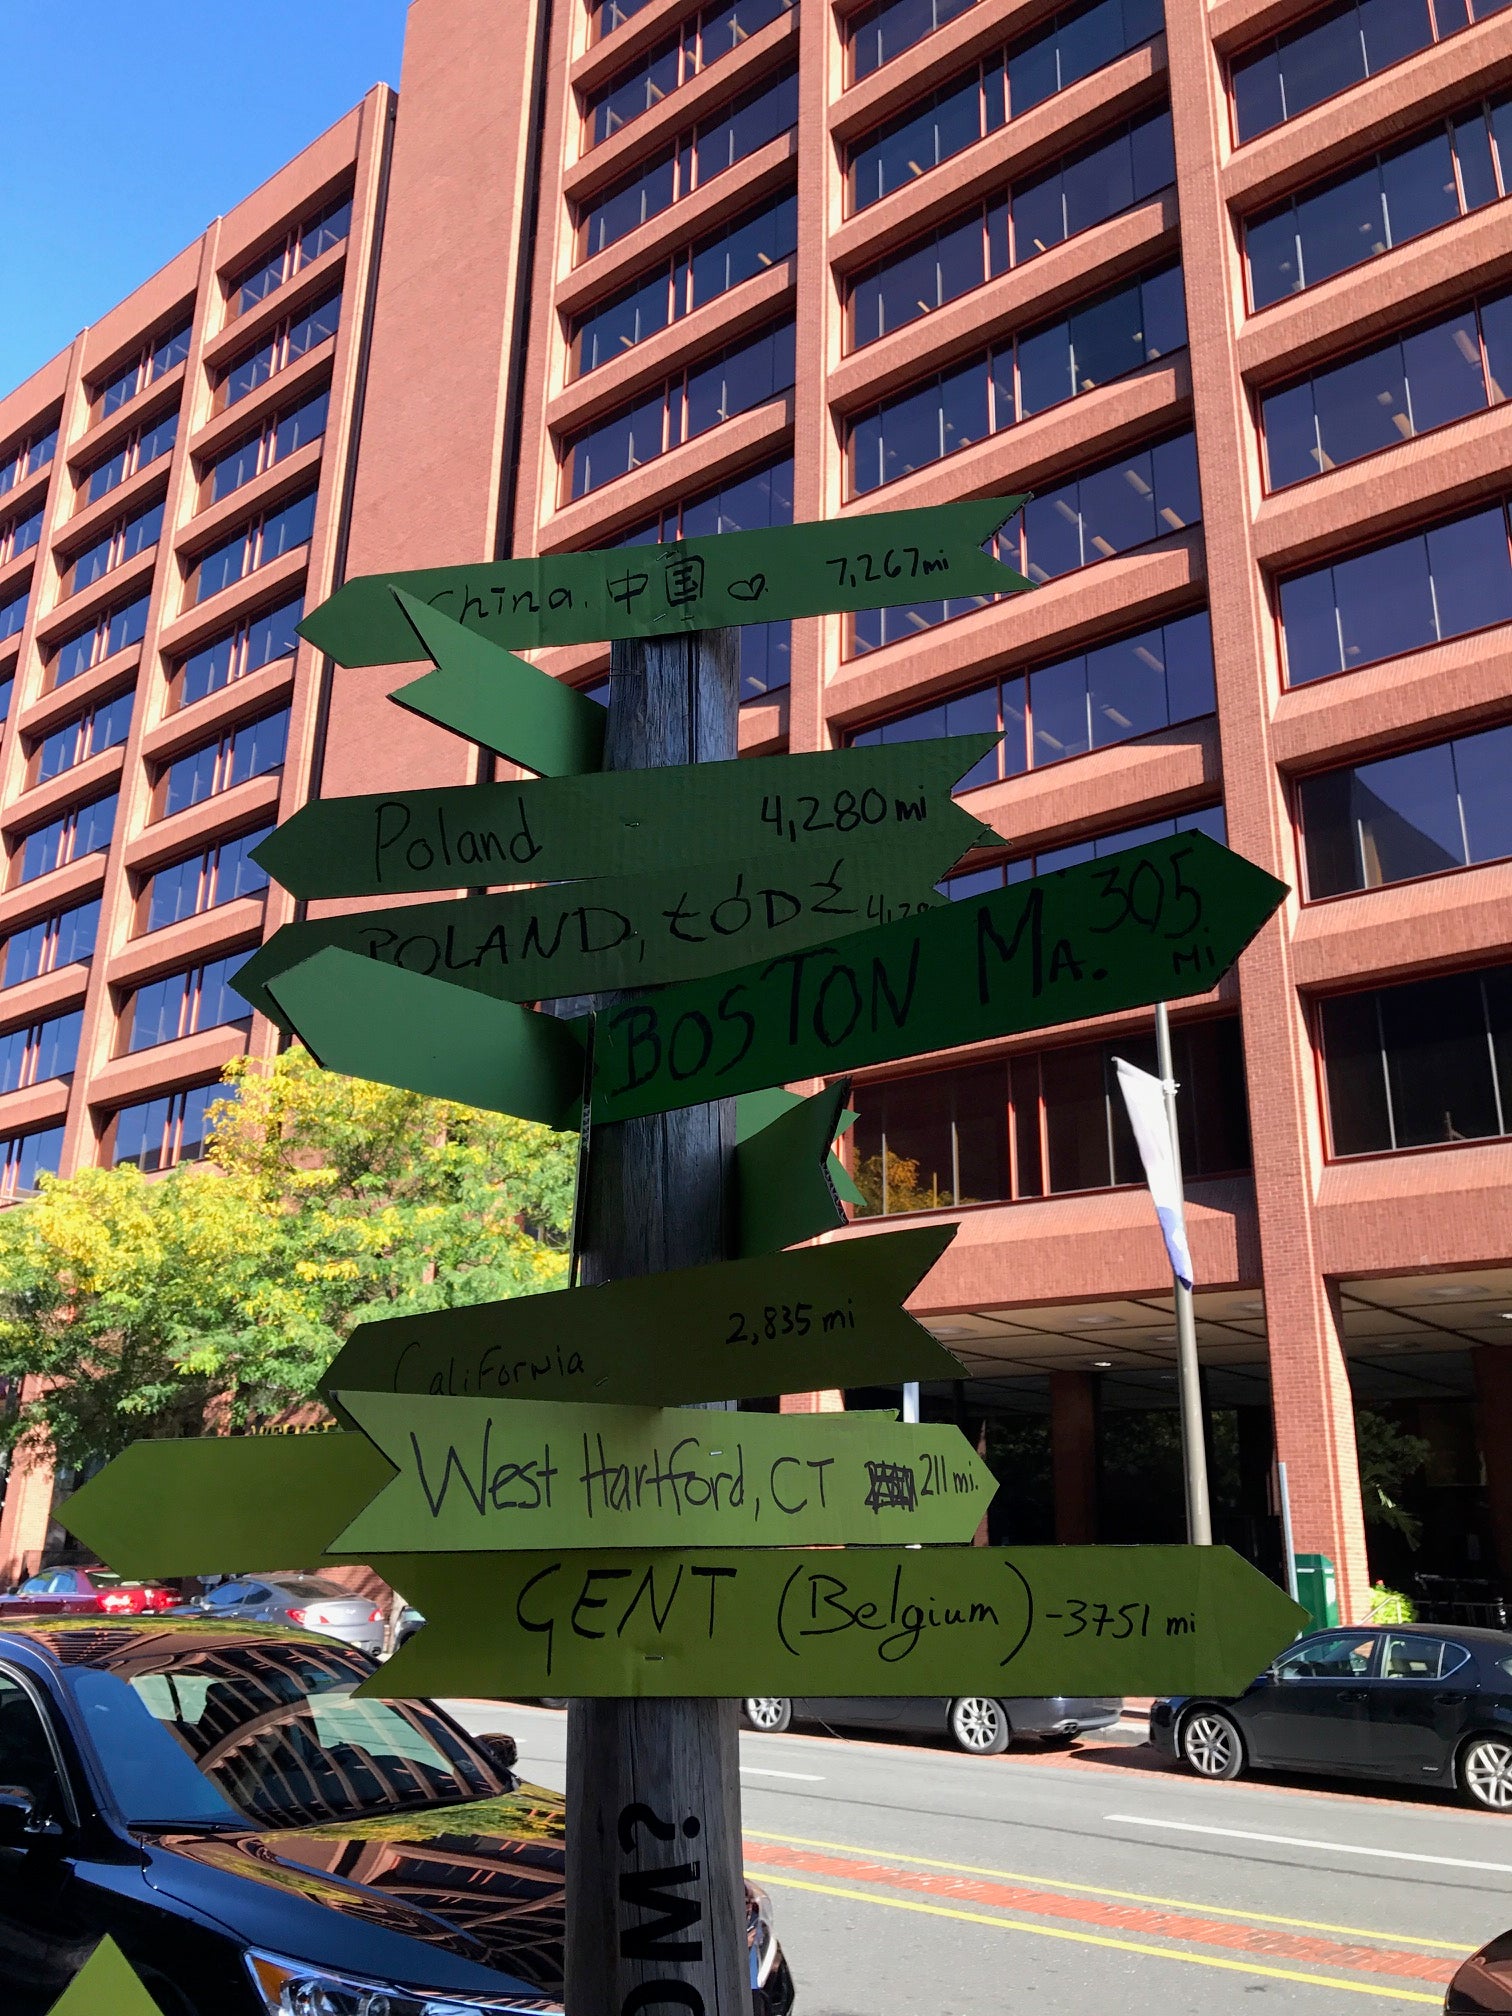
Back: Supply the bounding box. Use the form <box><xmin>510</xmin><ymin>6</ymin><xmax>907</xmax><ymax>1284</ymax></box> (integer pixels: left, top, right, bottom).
<box><xmin>1232</xmin><ymin>0</ymin><xmax>1508</xmax><ymax>141</ymax></box>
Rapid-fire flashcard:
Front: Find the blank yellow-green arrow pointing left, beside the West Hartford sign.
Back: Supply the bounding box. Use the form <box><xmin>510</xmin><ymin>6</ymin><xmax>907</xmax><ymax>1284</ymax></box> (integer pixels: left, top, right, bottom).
<box><xmin>58</xmin><ymin>1433</ymin><xmax>393</xmax><ymax>1581</ymax></box>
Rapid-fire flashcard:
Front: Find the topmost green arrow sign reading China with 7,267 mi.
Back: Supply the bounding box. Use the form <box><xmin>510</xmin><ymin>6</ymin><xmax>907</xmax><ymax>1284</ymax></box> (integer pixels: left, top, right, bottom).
<box><xmin>300</xmin><ymin>496</ymin><xmax>1032</xmax><ymax>665</ymax></box>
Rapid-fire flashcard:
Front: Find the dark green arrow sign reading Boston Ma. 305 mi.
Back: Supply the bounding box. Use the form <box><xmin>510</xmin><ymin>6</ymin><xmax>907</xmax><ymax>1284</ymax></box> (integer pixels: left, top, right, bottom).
<box><xmin>591</xmin><ymin>833</ymin><xmax>1286</xmax><ymax>1121</ymax></box>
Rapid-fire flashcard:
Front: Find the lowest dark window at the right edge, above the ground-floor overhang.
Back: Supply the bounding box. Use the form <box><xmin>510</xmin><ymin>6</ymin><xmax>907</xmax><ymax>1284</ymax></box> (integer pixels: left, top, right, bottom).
<box><xmin>1318</xmin><ymin>968</ymin><xmax>1512</xmax><ymax>1155</ymax></box>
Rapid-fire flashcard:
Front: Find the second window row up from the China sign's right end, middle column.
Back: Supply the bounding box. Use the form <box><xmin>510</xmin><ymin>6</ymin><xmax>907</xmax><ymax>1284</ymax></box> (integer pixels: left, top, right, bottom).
<box><xmin>847</xmin><ymin>111</ymin><xmax>1175</xmax><ymax>349</ymax></box>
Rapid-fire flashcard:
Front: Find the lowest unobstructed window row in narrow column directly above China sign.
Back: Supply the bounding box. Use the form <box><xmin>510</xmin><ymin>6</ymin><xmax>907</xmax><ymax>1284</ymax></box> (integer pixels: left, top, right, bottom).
<box><xmin>562</xmin><ymin>323</ymin><xmax>794</xmax><ymax>498</ymax></box>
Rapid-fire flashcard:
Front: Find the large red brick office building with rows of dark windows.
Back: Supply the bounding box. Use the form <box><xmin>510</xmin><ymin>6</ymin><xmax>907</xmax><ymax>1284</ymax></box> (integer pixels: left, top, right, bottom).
<box><xmin>0</xmin><ymin>0</ymin><xmax>1512</xmax><ymax>1611</ymax></box>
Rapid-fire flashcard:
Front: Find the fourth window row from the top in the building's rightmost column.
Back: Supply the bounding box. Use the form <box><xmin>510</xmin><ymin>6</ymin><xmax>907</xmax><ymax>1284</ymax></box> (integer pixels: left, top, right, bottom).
<box><xmin>1280</xmin><ymin>504</ymin><xmax>1512</xmax><ymax>685</ymax></box>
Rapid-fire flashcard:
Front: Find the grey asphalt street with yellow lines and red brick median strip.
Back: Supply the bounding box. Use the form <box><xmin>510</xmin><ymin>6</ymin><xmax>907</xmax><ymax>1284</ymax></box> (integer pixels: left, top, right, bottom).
<box><xmin>441</xmin><ymin>1702</ymin><xmax>1512</xmax><ymax>2016</ymax></box>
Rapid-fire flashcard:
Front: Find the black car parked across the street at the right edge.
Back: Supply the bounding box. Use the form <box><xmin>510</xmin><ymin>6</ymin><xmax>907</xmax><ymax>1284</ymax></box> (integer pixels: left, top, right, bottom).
<box><xmin>1149</xmin><ymin>1625</ymin><xmax>1512</xmax><ymax>1814</ymax></box>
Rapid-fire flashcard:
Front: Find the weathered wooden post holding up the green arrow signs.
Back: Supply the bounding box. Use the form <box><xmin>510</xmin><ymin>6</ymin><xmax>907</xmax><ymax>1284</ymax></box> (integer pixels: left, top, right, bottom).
<box><xmin>566</xmin><ymin>629</ymin><xmax>750</xmax><ymax>2016</ymax></box>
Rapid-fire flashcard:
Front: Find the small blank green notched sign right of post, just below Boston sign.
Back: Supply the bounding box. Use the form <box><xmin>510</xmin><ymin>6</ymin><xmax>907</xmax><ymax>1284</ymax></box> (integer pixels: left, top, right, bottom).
<box><xmin>736</xmin><ymin>1079</ymin><xmax>855</xmax><ymax>1256</ymax></box>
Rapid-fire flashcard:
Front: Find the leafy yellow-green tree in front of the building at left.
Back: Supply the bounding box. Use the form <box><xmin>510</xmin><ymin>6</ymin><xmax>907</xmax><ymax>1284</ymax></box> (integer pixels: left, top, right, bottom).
<box><xmin>0</xmin><ymin>1048</ymin><xmax>575</xmax><ymax>1466</ymax></box>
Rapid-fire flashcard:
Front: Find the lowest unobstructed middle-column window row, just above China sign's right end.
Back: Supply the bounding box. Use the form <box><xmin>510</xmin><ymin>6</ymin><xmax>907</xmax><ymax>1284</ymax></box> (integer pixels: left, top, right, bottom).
<box><xmin>847</xmin><ymin>266</ymin><xmax>1187</xmax><ymax>496</ymax></box>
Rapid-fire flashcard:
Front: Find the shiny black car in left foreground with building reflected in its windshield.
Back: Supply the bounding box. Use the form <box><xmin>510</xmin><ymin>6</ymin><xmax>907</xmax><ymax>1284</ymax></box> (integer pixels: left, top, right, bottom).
<box><xmin>0</xmin><ymin>1617</ymin><xmax>792</xmax><ymax>2016</ymax></box>
